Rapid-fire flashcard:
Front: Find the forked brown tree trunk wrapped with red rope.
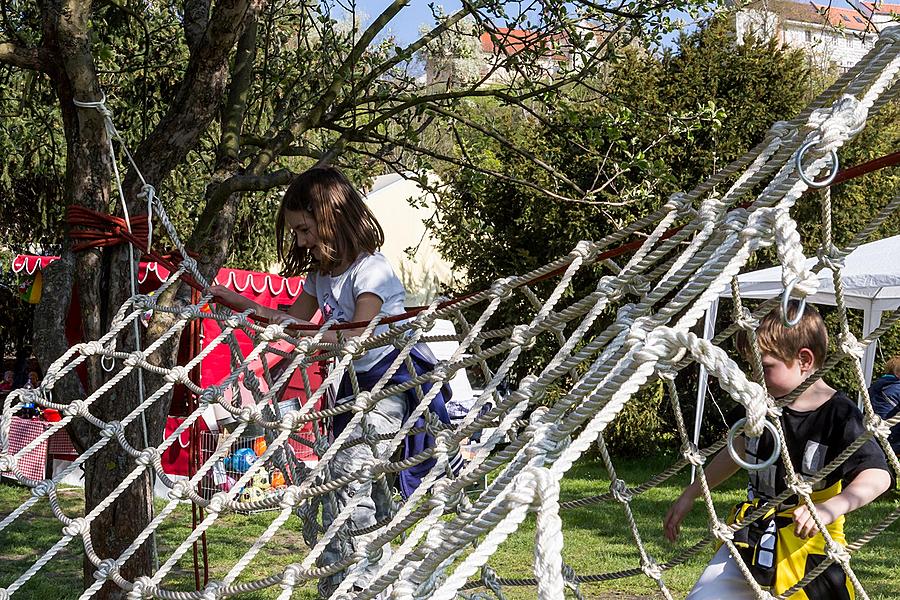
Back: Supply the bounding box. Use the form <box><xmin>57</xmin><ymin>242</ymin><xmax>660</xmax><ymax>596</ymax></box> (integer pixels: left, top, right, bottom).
<box><xmin>35</xmin><ymin>0</ymin><xmax>255</xmax><ymax>598</ymax></box>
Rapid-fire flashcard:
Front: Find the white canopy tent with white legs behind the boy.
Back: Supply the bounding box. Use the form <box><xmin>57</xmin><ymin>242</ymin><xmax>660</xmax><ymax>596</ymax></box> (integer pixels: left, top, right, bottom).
<box><xmin>694</xmin><ymin>235</ymin><xmax>900</xmax><ymax>450</ymax></box>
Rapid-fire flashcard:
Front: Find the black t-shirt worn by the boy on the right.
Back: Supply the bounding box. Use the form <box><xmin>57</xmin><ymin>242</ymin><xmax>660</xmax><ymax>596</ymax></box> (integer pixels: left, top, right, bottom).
<box><xmin>728</xmin><ymin>392</ymin><xmax>893</xmax><ymax>506</ymax></box>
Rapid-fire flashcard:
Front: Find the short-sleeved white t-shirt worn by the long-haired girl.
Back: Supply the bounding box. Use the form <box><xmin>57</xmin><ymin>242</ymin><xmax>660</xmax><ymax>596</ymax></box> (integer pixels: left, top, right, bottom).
<box><xmin>303</xmin><ymin>252</ymin><xmax>406</xmax><ymax>371</ymax></box>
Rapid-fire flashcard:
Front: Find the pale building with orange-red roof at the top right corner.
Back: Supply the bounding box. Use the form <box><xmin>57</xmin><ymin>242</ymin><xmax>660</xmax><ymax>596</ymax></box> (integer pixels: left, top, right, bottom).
<box><xmin>734</xmin><ymin>0</ymin><xmax>900</xmax><ymax>73</ymax></box>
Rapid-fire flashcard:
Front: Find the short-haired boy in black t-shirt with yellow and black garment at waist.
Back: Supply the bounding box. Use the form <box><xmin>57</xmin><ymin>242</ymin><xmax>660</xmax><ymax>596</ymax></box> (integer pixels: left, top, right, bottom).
<box><xmin>664</xmin><ymin>302</ymin><xmax>891</xmax><ymax>600</ymax></box>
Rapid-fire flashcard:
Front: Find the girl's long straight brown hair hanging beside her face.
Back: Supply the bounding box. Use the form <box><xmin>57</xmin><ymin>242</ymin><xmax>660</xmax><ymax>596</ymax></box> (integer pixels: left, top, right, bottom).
<box><xmin>275</xmin><ymin>167</ymin><xmax>384</xmax><ymax>276</ymax></box>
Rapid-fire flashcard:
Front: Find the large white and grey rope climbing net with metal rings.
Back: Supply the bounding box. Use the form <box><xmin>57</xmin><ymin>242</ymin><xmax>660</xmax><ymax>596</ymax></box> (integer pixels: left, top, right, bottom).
<box><xmin>0</xmin><ymin>28</ymin><xmax>900</xmax><ymax>600</ymax></box>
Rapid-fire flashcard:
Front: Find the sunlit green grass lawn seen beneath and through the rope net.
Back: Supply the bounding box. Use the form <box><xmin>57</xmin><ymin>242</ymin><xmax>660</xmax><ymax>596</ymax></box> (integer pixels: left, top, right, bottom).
<box><xmin>0</xmin><ymin>459</ymin><xmax>900</xmax><ymax>600</ymax></box>
